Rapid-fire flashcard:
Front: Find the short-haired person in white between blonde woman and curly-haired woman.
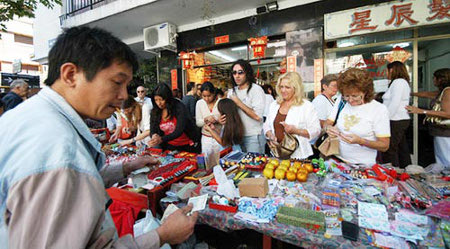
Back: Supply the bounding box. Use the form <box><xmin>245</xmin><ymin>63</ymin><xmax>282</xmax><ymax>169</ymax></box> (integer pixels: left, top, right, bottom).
<box><xmin>312</xmin><ymin>74</ymin><xmax>338</xmax><ymax>127</ymax></box>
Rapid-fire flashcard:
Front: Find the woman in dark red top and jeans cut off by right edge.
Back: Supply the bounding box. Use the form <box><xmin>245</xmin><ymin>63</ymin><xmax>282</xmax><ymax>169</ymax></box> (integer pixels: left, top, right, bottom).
<box><xmin>406</xmin><ymin>68</ymin><xmax>450</xmax><ymax>169</ymax></box>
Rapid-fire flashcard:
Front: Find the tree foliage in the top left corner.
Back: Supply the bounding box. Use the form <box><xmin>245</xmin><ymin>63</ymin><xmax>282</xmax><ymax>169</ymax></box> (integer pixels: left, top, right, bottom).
<box><xmin>0</xmin><ymin>0</ymin><xmax>61</xmax><ymax>31</ymax></box>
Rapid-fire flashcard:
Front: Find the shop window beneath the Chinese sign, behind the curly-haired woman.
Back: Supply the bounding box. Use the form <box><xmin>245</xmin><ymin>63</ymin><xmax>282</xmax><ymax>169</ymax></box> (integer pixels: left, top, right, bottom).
<box><xmin>325</xmin><ymin>42</ymin><xmax>413</xmax><ymax>92</ymax></box>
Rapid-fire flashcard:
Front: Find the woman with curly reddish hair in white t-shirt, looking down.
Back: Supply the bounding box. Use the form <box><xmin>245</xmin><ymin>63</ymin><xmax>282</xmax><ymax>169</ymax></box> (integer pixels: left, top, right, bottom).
<box><xmin>324</xmin><ymin>68</ymin><xmax>391</xmax><ymax>166</ymax></box>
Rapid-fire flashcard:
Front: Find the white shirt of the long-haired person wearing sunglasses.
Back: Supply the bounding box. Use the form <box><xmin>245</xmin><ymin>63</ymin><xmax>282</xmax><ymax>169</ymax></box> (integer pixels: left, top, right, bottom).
<box><xmin>228</xmin><ymin>84</ymin><xmax>266</xmax><ymax>136</ymax></box>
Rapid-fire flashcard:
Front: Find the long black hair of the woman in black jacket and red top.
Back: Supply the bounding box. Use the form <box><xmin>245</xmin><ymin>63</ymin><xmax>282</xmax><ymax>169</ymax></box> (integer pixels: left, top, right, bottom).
<box><xmin>150</xmin><ymin>83</ymin><xmax>175</xmax><ymax>124</ymax></box>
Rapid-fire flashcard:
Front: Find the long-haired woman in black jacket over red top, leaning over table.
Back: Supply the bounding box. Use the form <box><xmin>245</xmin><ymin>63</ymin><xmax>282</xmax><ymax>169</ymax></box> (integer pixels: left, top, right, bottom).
<box><xmin>147</xmin><ymin>83</ymin><xmax>198</xmax><ymax>152</ymax></box>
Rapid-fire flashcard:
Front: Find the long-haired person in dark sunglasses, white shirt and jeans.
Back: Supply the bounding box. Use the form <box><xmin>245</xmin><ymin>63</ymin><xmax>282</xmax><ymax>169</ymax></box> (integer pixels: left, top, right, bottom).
<box><xmin>228</xmin><ymin>60</ymin><xmax>266</xmax><ymax>153</ymax></box>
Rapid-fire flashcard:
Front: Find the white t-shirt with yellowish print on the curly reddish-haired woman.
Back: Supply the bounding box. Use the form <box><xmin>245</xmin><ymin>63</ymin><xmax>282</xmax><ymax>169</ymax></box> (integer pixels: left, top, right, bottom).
<box><xmin>328</xmin><ymin>100</ymin><xmax>391</xmax><ymax>166</ymax></box>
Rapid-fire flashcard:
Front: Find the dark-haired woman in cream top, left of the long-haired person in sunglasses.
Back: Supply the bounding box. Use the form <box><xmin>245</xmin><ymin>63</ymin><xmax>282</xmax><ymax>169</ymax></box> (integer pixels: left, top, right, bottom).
<box><xmin>195</xmin><ymin>81</ymin><xmax>222</xmax><ymax>165</ymax></box>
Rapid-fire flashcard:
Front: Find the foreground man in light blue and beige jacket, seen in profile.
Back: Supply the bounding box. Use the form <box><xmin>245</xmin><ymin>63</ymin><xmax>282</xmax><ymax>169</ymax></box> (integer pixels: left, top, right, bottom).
<box><xmin>0</xmin><ymin>27</ymin><xmax>198</xmax><ymax>249</ymax></box>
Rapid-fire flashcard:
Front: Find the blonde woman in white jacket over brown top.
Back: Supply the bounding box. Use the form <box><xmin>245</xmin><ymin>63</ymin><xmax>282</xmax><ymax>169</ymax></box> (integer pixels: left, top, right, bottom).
<box><xmin>263</xmin><ymin>72</ymin><xmax>320</xmax><ymax>159</ymax></box>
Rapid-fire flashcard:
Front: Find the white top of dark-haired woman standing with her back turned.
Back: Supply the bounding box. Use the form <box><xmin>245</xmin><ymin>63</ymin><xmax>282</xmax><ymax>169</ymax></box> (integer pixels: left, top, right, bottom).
<box><xmin>383</xmin><ymin>79</ymin><xmax>411</xmax><ymax>120</ymax></box>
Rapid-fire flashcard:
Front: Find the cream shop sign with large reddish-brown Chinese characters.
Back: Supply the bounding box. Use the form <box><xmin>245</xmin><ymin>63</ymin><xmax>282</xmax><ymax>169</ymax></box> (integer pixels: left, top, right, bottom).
<box><xmin>324</xmin><ymin>0</ymin><xmax>450</xmax><ymax>40</ymax></box>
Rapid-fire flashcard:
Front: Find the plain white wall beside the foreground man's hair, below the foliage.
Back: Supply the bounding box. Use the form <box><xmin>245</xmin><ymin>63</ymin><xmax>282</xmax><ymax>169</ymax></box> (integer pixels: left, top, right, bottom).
<box><xmin>33</xmin><ymin>4</ymin><xmax>62</xmax><ymax>64</ymax></box>
